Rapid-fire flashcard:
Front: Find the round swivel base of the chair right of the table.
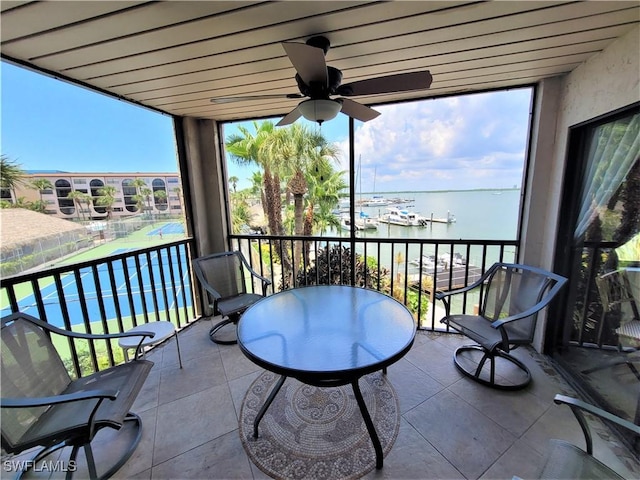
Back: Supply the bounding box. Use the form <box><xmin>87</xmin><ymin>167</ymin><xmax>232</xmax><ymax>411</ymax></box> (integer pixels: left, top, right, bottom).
<box><xmin>453</xmin><ymin>345</ymin><xmax>531</xmax><ymax>390</ymax></box>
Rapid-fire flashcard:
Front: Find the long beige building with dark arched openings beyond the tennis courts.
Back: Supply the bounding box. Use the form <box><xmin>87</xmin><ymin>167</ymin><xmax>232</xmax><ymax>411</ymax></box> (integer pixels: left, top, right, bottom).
<box><xmin>2</xmin><ymin>171</ymin><xmax>182</xmax><ymax>220</ymax></box>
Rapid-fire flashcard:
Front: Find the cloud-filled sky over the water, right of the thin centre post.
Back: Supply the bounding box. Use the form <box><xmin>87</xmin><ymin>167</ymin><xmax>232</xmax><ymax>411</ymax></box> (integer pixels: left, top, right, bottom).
<box><xmin>345</xmin><ymin>89</ymin><xmax>530</xmax><ymax>191</ymax></box>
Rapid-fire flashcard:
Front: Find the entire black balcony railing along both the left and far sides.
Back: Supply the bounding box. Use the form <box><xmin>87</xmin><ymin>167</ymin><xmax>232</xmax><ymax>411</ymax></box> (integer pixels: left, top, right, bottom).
<box><xmin>0</xmin><ymin>235</ymin><xmax>518</xmax><ymax>376</ymax></box>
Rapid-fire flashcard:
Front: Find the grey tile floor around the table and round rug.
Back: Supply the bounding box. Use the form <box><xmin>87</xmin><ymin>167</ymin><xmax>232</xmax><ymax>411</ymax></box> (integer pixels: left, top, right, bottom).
<box><xmin>5</xmin><ymin>319</ymin><xmax>640</xmax><ymax>480</ymax></box>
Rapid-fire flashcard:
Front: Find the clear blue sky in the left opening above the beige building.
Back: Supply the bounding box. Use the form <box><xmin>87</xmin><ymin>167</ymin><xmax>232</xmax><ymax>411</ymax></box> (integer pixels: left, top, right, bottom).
<box><xmin>0</xmin><ymin>62</ymin><xmax>178</xmax><ymax>172</ymax></box>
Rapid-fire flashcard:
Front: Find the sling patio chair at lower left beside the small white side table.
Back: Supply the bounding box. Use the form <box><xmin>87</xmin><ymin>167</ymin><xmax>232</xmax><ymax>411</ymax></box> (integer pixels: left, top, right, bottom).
<box><xmin>0</xmin><ymin>313</ymin><xmax>153</xmax><ymax>479</ymax></box>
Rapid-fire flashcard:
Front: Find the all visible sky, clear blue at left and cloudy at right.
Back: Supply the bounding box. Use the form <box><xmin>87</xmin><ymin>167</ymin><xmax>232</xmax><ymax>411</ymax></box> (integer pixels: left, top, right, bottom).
<box><xmin>0</xmin><ymin>62</ymin><xmax>531</xmax><ymax>192</ymax></box>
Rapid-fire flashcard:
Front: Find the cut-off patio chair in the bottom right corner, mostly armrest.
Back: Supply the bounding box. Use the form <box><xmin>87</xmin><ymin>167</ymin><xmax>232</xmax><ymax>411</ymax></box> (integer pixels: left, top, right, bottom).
<box><xmin>539</xmin><ymin>395</ymin><xmax>640</xmax><ymax>480</ymax></box>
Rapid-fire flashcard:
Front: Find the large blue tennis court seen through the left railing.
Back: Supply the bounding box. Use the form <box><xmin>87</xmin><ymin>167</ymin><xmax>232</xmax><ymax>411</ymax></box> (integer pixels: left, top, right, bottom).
<box><xmin>1</xmin><ymin>246</ymin><xmax>191</xmax><ymax>327</ymax></box>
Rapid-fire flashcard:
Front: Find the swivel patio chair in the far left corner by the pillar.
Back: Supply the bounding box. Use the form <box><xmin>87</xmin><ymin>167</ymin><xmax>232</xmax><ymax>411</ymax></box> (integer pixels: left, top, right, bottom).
<box><xmin>193</xmin><ymin>251</ymin><xmax>271</xmax><ymax>345</ymax></box>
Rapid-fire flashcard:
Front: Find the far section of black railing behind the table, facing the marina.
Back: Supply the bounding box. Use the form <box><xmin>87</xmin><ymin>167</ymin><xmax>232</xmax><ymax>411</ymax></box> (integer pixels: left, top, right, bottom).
<box><xmin>229</xmin><ymin>235</ymin><xmax>518</xmax><ymax>330</ymax></box>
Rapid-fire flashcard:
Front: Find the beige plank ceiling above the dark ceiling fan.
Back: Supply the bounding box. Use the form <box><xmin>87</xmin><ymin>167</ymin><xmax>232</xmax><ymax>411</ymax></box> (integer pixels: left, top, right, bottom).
<box><xmin>0</xmin><ymin>0</ymin><xmax>640</xmax><ymax>124</ymax></box>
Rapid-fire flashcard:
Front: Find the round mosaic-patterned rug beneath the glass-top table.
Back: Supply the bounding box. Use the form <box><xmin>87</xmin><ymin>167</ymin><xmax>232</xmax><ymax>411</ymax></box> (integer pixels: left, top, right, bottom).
<box><xmin>240</xmin><ymin>372</ymin><xmax>400</xmax><ymax>479</ymax></box>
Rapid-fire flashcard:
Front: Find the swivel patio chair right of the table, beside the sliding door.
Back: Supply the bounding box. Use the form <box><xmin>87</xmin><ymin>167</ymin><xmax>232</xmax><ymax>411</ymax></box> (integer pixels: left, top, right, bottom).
<box><xmin>435</xmin><ymin>263</ymin><xmax>567</xmax><ymax>390</ymax></box>
